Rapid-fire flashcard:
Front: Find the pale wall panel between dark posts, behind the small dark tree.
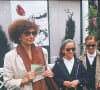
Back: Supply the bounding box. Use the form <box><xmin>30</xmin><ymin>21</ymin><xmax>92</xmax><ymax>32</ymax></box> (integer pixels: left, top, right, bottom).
<box><xmin>49</xmin><ymin>0</ymin><xmax>80</xmax><ymax>63</ymax></box>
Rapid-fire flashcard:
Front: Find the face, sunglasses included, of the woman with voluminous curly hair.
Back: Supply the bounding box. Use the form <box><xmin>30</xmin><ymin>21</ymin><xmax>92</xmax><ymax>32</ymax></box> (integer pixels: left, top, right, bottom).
<box><xmin>21</xmin><ymin>29</ymin><xmax>37</xmax><ymax>46</ymax></box>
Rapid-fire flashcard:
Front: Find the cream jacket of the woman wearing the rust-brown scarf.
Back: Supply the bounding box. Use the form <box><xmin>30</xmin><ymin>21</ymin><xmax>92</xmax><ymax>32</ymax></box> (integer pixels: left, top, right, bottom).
<box><xmin>3</xmin><ymin>48</ymin><xmax>48</xmax><ymax>90</ymax></box>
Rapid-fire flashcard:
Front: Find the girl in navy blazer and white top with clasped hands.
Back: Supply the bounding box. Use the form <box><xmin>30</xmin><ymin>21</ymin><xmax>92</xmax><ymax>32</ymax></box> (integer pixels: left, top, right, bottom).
<box><xmin>52</xmin><ymin>39</ymin><xmax>88</xmax><ymax>90</ymax></box>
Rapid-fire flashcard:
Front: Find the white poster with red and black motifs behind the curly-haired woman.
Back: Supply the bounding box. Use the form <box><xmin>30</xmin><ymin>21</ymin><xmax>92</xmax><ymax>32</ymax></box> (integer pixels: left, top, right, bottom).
<box><xmin>10</xmin><ymin>1</ymin><xmax>49</xmax><ymax>46</ymax></box>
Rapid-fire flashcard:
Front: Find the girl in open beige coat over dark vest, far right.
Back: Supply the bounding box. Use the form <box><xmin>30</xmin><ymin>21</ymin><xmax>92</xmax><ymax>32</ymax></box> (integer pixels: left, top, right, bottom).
<box><xmin>80</xmin><ymin>35</ymin><xmax>100</xmax><ymax>90</ymax></box>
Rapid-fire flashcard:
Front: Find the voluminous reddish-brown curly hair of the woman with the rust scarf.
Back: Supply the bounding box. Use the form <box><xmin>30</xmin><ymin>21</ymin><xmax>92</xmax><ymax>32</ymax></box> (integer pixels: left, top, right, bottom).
<box><xmin>8</xmin><ymin>19</ymin><xmax>39</xmax><ymax>44</ymax></box>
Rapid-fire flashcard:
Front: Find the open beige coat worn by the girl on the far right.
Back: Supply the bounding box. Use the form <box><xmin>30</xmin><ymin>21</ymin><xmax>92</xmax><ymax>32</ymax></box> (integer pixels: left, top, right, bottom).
<box><xmin>80</xmin><ymin>50</ymin><xmax>100</xmax><ymax>85</ymax></box>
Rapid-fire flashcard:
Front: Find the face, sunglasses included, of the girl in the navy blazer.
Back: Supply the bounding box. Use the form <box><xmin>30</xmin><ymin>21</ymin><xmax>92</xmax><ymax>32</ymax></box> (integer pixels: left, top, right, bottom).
<box><xmin>63</xmin><ymin>42</ymin><xmax>75</xmax><ymax>60</ymax></box>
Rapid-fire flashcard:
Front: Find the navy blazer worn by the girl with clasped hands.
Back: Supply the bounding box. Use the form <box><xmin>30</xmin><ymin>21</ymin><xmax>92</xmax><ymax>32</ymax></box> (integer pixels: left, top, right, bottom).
<box><xmin>52</xmin><ymin>58</ymin><xmax>88</xmax><ymax>90</ymax></box>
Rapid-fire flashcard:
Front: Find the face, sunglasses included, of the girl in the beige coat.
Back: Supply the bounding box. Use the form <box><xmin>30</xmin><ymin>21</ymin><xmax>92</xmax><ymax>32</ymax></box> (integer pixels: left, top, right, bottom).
<box><xmin>86</xmin><ymin>39</ymin><xmax>97</xmax><ymax>54</ymax></box>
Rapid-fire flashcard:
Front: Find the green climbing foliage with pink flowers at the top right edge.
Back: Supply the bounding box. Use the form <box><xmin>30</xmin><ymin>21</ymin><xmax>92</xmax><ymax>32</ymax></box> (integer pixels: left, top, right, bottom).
<box><xmin>86</xmin><ymin>0</ymin><xmax>100</xmax><ymax>50</ymax></box>
